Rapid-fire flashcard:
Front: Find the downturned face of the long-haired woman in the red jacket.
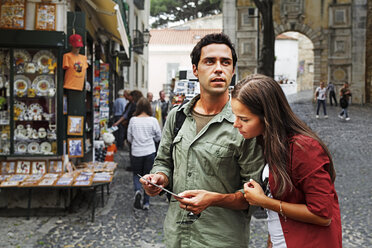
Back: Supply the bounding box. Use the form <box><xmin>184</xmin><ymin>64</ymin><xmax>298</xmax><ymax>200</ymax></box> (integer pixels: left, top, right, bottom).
<box><xmin>231</xmin><ymin>98</ymin><xmax>265</xmax><ymax>139</ymax></box>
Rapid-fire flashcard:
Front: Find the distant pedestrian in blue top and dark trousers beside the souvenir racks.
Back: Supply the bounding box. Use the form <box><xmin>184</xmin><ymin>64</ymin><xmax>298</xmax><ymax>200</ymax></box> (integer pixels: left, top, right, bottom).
<box><xmin>114</xmin><ymin>89</ymin><xmax>129</xmax><ymax>149</ymax></box>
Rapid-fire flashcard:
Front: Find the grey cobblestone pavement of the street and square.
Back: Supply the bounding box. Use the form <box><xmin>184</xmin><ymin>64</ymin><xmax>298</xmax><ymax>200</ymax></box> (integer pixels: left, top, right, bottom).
<box><xmin>0</xmin><ymin>91</ymin><xmax>372</xmax><ymax>248</ymax></box>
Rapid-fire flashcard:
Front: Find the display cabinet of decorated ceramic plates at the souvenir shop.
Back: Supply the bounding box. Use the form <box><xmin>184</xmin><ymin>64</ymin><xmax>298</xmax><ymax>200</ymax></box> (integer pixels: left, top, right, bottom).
<box><xmin>0</xmin><ymin>31</ymin><xmax>63</xmax><ymax>157</ymax></box>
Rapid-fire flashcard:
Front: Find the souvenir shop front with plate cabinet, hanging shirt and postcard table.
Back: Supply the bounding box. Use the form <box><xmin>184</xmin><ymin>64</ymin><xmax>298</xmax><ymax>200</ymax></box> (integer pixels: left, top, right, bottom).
<box><xmin>0</xmin><ymin>1</ymin><xmax>120</xmax><ymax>220</ymax></box>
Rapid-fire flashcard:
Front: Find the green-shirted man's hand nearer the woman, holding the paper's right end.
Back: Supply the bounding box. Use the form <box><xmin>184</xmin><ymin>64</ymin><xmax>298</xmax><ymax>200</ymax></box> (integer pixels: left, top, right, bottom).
<box><xmin>175</xmin><ymin>190</ymin><xmax>218</xmax><ymax>215</ymax></box>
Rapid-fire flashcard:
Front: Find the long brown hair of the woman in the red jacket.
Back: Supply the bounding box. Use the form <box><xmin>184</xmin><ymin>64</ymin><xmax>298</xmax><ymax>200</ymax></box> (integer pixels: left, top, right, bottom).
<box><xmin>231</xmin><ymin>74</ymin><xmax>336</xmax><ymax>197</ymax></box>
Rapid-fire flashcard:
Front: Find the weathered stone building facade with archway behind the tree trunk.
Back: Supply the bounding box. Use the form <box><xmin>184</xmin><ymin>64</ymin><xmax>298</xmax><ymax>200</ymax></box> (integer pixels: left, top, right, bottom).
<box><xmin>223</xmin><ymin>0</ymin><xmax>372</xmax><ymax>103</ymax></box>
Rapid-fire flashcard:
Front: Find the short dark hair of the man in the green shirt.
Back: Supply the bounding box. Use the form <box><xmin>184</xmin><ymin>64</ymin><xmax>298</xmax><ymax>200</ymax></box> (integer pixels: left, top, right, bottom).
<box><xmin>190</xmin><ymin>33</ymin><xmax>238</xmax><ymax>68</ymax></box>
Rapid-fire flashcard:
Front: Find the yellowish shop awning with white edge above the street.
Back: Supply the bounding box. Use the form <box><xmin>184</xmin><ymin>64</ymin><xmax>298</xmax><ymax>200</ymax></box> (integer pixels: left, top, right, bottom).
<box><xmin>83</xmin><ymin>0</ymin><xmax>129</xmax><ymax>57</ymax></box>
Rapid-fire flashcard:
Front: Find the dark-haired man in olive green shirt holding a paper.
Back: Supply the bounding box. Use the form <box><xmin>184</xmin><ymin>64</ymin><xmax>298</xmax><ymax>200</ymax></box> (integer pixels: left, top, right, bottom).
<box><xmin>141</xmin><ymin>33</ymin><xmax>264</xmax><ymax>248</ymax></box>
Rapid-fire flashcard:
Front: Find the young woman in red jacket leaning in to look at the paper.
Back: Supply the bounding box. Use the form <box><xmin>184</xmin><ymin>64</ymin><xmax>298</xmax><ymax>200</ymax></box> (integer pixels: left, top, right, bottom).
<box><xmin>231</xmin><ymin>75</ymin><xmax>342</xmax><ymax>248</ymax></box>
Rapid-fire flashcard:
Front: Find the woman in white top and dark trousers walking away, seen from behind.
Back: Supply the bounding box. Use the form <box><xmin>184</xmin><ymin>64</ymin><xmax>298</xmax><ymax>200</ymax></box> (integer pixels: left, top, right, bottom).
<box><xmin>127</xmin><ymin>97</ymin><xmax>161</xmax><ymax>210</ymax></box>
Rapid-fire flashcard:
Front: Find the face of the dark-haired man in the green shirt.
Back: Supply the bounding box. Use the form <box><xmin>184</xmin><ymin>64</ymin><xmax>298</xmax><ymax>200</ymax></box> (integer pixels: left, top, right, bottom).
<box><xmin>193</xmin><ymin>44</ymin><xmax>235</xmax><ymax>95</ymax></box>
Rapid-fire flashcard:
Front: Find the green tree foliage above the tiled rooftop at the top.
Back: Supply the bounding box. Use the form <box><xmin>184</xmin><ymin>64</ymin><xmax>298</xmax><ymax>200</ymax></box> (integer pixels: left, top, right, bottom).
<box><xmin>150</xmin><ymin>0</ymin><xmax>222</xmax><ymax>28</ymax></box>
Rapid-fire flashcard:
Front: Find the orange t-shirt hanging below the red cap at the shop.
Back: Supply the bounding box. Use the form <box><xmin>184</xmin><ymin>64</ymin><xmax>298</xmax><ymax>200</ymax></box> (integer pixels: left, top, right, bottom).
<box><xmin>63</xmin><ymin>52</ymin><xmax>88</xmax><ymax>91</ymax></box>
